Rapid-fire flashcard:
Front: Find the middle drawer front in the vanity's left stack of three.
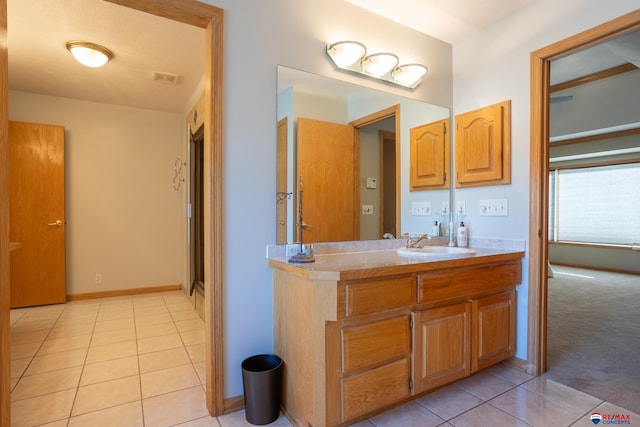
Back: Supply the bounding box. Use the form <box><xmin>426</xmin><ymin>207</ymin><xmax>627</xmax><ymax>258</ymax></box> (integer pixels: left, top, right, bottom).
<box><xmin>342</xmin><ymin>316</ymin><xmax>411</xmax><ymax>373</ymax></box>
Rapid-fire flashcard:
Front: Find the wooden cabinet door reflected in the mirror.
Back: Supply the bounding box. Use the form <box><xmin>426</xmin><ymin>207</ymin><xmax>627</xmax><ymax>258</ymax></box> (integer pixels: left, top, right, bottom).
<box><xmin>409</xmin><ymin>119</ymin><xmax>449</xmax><ymax>191</ymax></box>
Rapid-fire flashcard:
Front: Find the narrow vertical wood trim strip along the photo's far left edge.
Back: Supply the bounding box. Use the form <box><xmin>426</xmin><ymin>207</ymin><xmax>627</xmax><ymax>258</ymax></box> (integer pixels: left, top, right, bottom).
<box><xmin>0</xmin><ymin>0</ymin><xmax>11</xmax><ymax>427</ymax></box>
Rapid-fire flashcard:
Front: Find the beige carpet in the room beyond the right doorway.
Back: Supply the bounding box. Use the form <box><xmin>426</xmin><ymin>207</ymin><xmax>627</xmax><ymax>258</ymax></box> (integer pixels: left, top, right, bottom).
<box><xmin>544</xmin><ymin>265</ymin><xmax>640</xmax><ymax>413</ymax></box>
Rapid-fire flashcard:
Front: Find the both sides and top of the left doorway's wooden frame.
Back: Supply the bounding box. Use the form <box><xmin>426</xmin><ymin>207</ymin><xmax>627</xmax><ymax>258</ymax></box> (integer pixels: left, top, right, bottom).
<box><xmin>0</xmin><ymin>0</ymin><xmax>225</xmax><ymax>427</ymax></box>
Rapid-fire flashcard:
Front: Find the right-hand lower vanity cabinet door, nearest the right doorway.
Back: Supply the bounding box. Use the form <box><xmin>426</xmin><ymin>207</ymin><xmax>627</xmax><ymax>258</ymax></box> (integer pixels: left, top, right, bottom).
<box><xmin>471</xmin><ymin>291</ymin><xmax>516</xmax><ymax>372</ymax></box>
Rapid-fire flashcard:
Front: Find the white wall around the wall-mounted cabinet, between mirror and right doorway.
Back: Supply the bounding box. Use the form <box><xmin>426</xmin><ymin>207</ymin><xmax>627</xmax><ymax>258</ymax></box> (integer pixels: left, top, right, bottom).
<box><xmin>453</xmin><ymin>0</ymin><xmax>638</xmax><ymax>359</ymax></box>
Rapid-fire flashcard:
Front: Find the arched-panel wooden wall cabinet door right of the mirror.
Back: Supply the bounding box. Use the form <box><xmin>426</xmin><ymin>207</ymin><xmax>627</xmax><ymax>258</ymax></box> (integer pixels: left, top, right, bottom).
<box><xmin>455</xmin><ymin>101</ymin><xmax>511</xmax><ymax>188</ymax></box>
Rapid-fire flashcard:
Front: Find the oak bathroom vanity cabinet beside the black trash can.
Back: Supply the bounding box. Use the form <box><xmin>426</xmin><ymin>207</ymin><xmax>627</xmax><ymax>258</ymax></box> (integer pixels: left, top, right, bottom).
<box><xmin>269</xmin><ymin>251</ymin><xmax>524</xmax><ymax>426</ymax></box>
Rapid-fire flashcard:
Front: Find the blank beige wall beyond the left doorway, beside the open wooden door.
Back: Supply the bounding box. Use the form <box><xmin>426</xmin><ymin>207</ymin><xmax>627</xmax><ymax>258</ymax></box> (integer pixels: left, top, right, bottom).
<box><xmin>9</xmin><ymin>91</ymin><xmax>184</xmax><ymax>294</ymax></box>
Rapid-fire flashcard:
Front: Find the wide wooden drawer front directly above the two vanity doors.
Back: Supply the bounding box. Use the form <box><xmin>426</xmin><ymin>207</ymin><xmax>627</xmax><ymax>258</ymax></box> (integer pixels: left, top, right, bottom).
<box><xmin>418</xmin><ymin>260</ymin><xmax>522</xmax><ymax>304</ymax></box>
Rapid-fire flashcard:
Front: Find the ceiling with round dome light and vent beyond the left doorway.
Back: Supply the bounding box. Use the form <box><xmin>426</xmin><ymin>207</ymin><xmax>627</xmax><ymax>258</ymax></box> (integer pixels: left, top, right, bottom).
<box><xmin>7</xmin><ymin>0</ymin><xmax>205</xmax><ymax>112</ymax></box>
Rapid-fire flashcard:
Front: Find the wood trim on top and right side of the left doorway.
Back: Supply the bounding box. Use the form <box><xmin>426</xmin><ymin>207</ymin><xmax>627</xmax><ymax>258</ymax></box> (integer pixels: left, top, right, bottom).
<box><xmin>105</xmin><ymin>0</ymin><xmax>225</xmax><ymax>416</ymax></box>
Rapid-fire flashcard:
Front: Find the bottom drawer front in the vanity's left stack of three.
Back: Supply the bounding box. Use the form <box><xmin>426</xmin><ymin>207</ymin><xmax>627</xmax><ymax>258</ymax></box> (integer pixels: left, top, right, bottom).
<box><xmin>342</xmin><ymin>358</ymin><xmax>410</xmax><ymax>422</ymax></box>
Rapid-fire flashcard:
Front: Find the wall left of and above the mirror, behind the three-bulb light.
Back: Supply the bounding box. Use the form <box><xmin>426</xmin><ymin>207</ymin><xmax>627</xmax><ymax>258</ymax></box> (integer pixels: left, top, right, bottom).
<box><xmin>206</xmin><ymin>0</ymin><xmax>452</xmax><ymax>397</ymax></box>
